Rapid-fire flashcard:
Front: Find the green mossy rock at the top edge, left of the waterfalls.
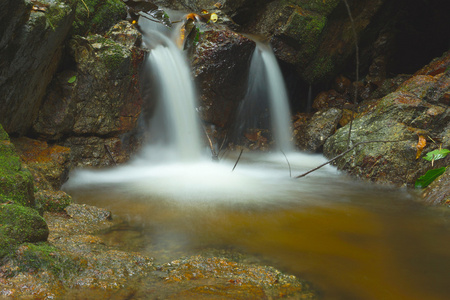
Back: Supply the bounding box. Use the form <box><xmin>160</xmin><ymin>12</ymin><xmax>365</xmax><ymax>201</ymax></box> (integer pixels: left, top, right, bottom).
<box><xmin>73</xmin><ymin>0</ymin><xmax>127</xmax><ymax>35</ymax></box>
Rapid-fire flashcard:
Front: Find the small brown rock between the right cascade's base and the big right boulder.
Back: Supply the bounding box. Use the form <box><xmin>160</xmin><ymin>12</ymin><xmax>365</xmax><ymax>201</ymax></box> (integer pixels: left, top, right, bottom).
<box><xmin>296</xmin><ymin>108</ymin><xmax>342</xmax><ymax>152</ymax></box>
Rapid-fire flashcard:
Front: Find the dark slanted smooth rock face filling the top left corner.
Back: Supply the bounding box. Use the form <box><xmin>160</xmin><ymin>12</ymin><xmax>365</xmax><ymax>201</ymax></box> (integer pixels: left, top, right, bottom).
<box><xmin>0</xmin><ymin>0</ymin><xmax>77</xmax><ymax>134</ymax></box>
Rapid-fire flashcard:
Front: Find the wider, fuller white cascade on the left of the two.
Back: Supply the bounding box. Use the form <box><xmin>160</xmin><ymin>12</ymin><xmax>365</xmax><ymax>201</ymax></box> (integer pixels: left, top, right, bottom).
<box><xmin>141</xmin><ymin>21</ymin><xmax>202</xmax><ymax>161</ymax></box>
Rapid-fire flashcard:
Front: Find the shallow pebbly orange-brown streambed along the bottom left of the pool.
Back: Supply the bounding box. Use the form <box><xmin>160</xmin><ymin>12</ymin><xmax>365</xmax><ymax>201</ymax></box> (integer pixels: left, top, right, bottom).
<box><xmin>0</xmin><ymin>204</ymin><xmax>316</xmax><ymax>299</ymax></box>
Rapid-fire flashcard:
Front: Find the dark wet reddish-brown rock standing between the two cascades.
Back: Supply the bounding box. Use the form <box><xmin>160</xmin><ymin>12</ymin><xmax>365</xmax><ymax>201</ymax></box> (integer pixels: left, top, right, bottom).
<box><xmin>192</xmin><ymin>29</ymin><xmax>255</xmax><ymax>127</ymax></box>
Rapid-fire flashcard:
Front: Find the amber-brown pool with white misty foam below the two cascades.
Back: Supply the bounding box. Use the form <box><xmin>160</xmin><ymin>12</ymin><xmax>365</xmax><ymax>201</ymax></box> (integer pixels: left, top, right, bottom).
<box><xmin>65</xmin><ymin>153</ymin><xmax>450</xmax><ymax>299</ymax></box>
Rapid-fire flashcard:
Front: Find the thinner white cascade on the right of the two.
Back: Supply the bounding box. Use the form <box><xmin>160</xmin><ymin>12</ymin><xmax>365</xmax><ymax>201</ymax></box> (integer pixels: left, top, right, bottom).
<box><xmin>237</xmin><ymin>42</ymin><xmax>294</xmax><ymax>152</ymax></box>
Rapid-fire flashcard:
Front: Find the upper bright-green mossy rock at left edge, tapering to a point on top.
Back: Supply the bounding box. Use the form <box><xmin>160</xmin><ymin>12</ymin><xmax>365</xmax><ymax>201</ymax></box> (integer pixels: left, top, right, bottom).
<box><xmin>0</xmin><ymin>125</ymin><xmax>35</xmax><ymax>207</ymax></box>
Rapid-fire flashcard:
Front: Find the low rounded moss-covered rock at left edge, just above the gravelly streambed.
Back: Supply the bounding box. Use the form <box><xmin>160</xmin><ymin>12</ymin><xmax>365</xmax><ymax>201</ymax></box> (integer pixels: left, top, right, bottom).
<box><xmin>0</xmin><ymin>204</ymin><xmax>49</xmax><ymax>257</ymax></box>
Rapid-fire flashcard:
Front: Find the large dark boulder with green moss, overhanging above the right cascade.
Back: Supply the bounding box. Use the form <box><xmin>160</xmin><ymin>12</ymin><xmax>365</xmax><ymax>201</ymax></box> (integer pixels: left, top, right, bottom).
<box><xmin>246</xmin><ymin>0</ymin><xmax>384</xmax><ymax>83</ymax></box>
